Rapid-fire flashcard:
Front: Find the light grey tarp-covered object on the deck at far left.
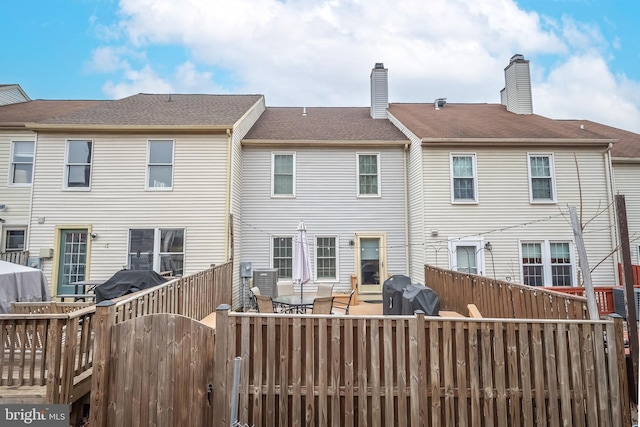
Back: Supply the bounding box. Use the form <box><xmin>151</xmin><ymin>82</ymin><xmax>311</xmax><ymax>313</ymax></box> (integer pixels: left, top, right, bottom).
<box><xmin>0</xmin><ymin>261</ymin><xmax>51</xmax><ymax>314</ymax></box>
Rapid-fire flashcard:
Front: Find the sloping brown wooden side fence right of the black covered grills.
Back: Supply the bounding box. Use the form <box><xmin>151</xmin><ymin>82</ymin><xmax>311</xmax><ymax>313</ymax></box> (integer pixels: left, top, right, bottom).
<box><xmin>424</xmin><ymin>265</ymin><xmax>589</xmax><ymax>319</ymax></box>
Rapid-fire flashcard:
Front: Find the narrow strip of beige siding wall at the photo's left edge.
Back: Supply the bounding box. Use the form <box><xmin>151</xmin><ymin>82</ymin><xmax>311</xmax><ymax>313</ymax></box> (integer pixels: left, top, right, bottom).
<box><xmin>0</xmin><ymin>129</ymin><xmax>36</xmax><ymax>252</ymax></box>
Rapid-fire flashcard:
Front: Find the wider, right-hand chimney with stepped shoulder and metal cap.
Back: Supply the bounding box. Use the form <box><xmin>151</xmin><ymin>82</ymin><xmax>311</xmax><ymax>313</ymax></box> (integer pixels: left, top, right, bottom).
<box><xmin>500</xmin><ymin>54</ymin><xmax>533</xmax><ymax>114</ymax></box>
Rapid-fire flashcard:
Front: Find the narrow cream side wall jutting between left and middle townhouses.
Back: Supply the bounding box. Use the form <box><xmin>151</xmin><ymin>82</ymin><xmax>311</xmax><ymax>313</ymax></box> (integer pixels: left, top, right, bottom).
<box><xmin>229</xmin><ymin>98</ymin><xmax>265</xmax><ymax>307</ymax></box>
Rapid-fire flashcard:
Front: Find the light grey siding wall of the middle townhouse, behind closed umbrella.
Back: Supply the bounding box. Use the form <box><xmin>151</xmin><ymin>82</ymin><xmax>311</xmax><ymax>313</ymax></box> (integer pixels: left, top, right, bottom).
<box><xmin>241</xmin><ymin>145</ymin><xmax>407</xmax><ymax>292</ymax></box>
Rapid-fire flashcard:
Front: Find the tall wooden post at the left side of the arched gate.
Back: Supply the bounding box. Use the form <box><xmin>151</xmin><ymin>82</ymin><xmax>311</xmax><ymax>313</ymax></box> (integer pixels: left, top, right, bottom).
<box><xmin>89</xmin><ymin>300</ymin><xmax>116</xmax><ymax>427</ymax></box>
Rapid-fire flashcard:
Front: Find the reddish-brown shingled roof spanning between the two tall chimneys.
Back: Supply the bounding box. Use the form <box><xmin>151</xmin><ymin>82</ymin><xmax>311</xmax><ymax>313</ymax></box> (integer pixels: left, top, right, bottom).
<box><xmin>389</xmin><ymin>103</ymin><xmax>608</xmax><ymax>142</ymax></box>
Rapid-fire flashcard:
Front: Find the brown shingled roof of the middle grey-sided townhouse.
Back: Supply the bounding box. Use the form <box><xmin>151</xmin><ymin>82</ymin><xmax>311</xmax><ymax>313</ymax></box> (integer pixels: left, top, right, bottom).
<box><xmin>243</xmin><ymin>107</ymin><xmax>408</xmax><ymax>143</ymax></box>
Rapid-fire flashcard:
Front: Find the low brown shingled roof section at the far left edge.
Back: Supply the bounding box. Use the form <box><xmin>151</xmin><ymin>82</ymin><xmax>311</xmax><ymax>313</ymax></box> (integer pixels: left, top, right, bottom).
<box><xmin>0</xmin><ymin>100</ymin><xmax>105</xmax><ymax>127</ymax></box>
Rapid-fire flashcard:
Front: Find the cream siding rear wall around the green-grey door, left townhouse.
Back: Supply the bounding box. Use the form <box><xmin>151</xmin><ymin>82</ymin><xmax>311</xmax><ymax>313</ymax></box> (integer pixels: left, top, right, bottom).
<box><xmin>29</xmin><ymin>130</ymin><xmax>228</xmax><ymax>289</ymax></box>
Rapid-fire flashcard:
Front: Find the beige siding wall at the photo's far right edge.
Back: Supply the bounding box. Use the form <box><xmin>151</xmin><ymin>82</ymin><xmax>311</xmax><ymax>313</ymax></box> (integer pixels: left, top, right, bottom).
<box><xmin>613</xmin><ymin>162</ymin><xmax>640</xmax><ymax>264</ymax></box>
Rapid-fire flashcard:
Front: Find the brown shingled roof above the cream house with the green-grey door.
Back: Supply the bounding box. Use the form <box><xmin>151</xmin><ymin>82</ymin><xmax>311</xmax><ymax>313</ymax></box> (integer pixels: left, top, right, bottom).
<box><xmin>27</xmin><ymin>94</ymin><xmax>262</xmax><ymax>128</ymax></box>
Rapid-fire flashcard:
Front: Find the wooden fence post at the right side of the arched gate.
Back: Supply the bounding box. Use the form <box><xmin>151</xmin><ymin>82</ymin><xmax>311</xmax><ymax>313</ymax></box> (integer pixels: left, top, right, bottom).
<box><xmin>214</xmin><ymin>304</ymin><xmax>231</xmax><ymax>427</ymax></box>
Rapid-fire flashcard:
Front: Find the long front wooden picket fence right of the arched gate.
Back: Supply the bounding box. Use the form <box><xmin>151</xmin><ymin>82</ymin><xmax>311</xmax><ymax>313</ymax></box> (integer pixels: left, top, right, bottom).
<box><xmin>212</xmin><ymin>307</ymin><xmax>631</xmax><ymax>427</ymax></box>
